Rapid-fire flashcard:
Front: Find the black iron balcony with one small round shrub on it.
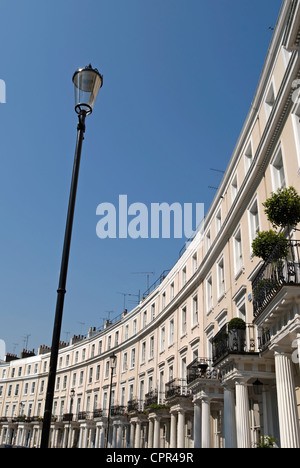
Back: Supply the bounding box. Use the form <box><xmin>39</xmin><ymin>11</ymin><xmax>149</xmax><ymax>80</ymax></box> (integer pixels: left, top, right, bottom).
<box><xmin>212</xmin><ymin>323</ymin><xmax>258</xmax><ymax>366</ymax></box>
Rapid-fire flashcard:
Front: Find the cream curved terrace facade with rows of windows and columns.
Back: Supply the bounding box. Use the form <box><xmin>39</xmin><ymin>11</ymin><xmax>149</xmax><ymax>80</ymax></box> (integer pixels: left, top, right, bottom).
<box><xmin>0</xmin><ymin>0</ymin><xmax>300</xmax><ymax>448</ymax></box>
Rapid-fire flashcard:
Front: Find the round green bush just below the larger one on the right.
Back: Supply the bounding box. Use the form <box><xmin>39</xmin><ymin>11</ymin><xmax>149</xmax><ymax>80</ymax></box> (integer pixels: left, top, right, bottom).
<box><xmin>252</xmin><ymin>229</ymin><xmax>288</xmax><ymax>262</ymax></box>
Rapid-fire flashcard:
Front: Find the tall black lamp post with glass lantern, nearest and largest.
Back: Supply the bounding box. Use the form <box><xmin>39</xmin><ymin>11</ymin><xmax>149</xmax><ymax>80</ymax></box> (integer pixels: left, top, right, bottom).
<box><xmin>40</xmin><ymin>65</ymin><xmax>103</xmax><ymax>448</ymax></box>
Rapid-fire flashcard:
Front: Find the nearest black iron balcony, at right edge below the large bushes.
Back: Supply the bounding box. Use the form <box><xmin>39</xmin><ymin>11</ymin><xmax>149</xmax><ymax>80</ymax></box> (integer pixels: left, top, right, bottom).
<box><xmin>252</xmin><ymin>241</ymin><xmax>300</xmax><ymax>318</ymax></box>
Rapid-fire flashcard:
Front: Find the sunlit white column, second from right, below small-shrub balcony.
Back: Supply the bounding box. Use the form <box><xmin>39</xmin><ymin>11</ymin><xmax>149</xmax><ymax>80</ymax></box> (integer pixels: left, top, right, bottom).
<box><xmin>235</xmin><ymin>380</ymin><xmax>251</xmax><ymax>448</ymax></box>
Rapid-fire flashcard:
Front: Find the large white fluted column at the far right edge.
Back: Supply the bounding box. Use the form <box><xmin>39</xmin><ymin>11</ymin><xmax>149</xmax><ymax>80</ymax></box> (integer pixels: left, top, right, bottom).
<box><xmin>275</xmin><ymin>350</ymin><xmax>300</xmax><ymax>448</ymax></box>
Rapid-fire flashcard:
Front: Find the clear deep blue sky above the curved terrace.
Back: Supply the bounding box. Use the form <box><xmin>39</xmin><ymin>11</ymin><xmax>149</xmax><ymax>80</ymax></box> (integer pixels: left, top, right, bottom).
<box><xmin>0</xmin><ymin>0</ymin><xmax>281</xmax><ymax>354</ymax></box>
